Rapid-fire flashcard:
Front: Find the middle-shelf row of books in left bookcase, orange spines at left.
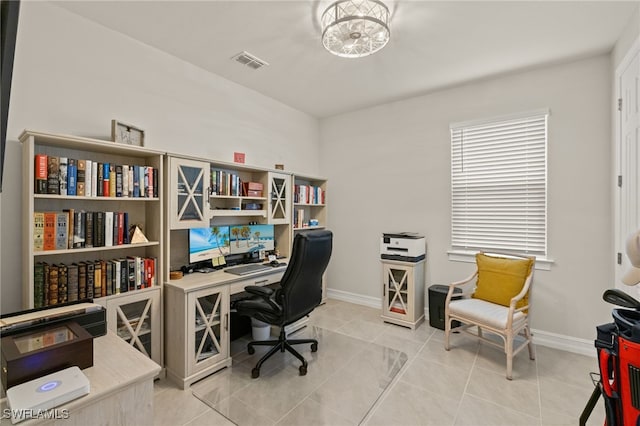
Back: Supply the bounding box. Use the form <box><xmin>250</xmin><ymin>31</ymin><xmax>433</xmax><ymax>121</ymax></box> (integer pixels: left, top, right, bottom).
<box><xmin>33</xmin><ymin>209</ymin><xmax>135</xmax><ymax>251</ymax></box>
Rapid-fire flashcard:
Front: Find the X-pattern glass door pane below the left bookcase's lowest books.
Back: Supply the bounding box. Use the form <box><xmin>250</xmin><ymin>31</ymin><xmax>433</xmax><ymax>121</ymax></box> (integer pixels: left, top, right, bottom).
<box><xmin>115</xmin><ymin>299</ymin><xmax>153</xmax><ymax>358</ymax></box>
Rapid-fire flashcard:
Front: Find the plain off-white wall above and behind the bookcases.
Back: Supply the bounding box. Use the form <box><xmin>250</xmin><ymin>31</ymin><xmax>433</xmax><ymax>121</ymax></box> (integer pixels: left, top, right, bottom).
<box><xmin>0</xmin><ymin>2</ymin><xmax>319</xmax><ymax>312</ymax></box>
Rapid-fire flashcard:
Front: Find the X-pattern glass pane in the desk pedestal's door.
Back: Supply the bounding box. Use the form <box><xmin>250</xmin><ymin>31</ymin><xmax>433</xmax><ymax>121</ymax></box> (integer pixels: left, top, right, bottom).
<box><xmin>193</xmin><ymin>293</ymin><xmax>223</xmax><ymax>365</ymax></box>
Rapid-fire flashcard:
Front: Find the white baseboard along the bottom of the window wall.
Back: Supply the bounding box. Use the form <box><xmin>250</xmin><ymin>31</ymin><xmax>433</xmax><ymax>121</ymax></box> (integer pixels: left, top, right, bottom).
<box><xmin>327</xmin><ymin>288</ymin><xmax>596</xmax><ymax>358</ymax></box>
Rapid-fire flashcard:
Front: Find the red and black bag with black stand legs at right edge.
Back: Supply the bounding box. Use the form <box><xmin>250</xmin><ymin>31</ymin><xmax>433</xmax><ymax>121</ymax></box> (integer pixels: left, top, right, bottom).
<box><xmin>580</xmin><ymin>289</ymin><xmax>640</xmax><ymax>426</ymax></box>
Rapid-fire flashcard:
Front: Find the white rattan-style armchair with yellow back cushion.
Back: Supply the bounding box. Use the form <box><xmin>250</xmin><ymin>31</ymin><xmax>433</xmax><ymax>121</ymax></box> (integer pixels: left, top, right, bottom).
<box><xmin>444</xmin><ymin>253</ymin><xmax>535</xmax><ymax>380</ymax></box>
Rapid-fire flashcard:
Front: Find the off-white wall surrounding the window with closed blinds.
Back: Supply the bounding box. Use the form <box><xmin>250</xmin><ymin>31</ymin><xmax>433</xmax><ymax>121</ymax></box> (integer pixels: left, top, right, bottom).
<box><xmin>321</xmin><ymin>55</ymin><xmax>613</xmax><ymax>340</ymax></box>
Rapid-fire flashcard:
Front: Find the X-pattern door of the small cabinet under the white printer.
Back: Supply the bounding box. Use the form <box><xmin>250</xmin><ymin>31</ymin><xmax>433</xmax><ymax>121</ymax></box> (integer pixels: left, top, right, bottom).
<box><xmin>382</xmin><ymin>263</ymin><xmax>415</xmax><ymax>318</ymax></box>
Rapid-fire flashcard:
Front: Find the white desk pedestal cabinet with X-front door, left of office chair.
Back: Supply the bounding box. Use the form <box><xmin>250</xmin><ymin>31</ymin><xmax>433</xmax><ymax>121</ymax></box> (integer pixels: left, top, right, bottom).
<box><xmin>165</xmin><ymin>284</ymin><xmax>231</xmax><ymax>389</ymax></box>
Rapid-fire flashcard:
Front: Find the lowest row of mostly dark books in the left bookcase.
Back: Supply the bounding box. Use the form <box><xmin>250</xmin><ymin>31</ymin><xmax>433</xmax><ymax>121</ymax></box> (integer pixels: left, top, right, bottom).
<box><xmin>33</xmin><ymin>256</ymin><xmax>157</xmax><ymax>308</ymax></box>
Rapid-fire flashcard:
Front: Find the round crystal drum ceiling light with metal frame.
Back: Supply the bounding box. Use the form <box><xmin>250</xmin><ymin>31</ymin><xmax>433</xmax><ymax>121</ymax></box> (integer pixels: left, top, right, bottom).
<box><xmin>322</xmin><ymin>0</ymin><xmax>391</xmax><ymax>58</ymax></box>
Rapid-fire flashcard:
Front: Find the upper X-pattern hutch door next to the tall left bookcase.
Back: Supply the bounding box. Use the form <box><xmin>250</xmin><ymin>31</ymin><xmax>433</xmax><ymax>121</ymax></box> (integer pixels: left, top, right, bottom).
<box><xmin>169</xmin><ymin>157</ymin><xmax>210</xmax><ymax>229</ymax></box>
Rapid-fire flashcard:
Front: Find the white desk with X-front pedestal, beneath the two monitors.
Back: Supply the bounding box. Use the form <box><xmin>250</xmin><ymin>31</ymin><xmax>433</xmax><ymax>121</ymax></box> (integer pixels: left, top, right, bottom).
<box><xmin>164</xmin><ymin>259</ymin><xmax>288</xmax><ymax>389</ymax></box>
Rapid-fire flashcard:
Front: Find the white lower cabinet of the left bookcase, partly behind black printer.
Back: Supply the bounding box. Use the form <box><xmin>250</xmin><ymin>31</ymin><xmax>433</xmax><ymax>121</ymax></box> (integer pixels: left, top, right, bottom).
<box><xmin>106</xmin><ymin>287</ymin><xmax>162</xmax><ymax>365</ymax></box>
